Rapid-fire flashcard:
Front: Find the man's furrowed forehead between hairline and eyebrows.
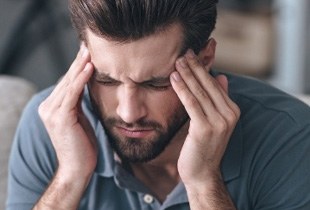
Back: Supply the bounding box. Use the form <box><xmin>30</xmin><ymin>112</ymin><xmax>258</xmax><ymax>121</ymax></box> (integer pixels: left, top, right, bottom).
<box><xmin>87</xmin><ymin>24</ymin><xmax>183</xmax><ymax>82</ymax></box>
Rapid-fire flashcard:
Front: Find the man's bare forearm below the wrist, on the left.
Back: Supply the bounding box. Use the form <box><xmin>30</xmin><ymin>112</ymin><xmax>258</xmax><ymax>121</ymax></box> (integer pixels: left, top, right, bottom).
<box><xmin>33</xmin><ymin>171</ymin><xmax>89</xmax><ymax>210</ymax></box>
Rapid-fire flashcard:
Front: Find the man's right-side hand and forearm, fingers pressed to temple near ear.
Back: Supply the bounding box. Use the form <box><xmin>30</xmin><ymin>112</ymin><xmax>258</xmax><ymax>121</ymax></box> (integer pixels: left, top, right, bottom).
<box><xmin>171</xmin><ymin>41</ymin><xmax>240</xmax><ymax>210</ymax></box>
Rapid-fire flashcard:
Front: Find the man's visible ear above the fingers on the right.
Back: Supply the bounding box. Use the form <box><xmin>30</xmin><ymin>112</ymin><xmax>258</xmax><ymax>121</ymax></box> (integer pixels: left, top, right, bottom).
<box><xmin>198</xmin><ymin>38</ymin><xmax>216</xmax><ymax>69</ymax></box>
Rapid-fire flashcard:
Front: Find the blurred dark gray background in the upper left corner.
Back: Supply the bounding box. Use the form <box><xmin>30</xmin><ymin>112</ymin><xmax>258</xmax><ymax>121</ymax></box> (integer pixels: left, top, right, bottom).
<box><xmin>0</xmin><ymin>0</ymin><xmax>78</xmax><ymax>89</ymax></box>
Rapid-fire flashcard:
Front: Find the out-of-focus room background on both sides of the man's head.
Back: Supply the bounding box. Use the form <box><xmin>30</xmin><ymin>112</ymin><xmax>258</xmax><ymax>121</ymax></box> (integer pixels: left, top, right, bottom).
<box><xmin>0</xmin><ymin>0</ymin><xmax>310</xmax><ymax>94</ymax></box>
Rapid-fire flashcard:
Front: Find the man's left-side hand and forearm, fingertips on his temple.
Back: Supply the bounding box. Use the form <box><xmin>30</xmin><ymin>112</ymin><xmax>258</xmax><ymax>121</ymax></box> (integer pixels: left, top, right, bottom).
<box><xmin>35</xmin><ymin>44</ymin><xmax>97</xmax><ymax>209</ymax></box>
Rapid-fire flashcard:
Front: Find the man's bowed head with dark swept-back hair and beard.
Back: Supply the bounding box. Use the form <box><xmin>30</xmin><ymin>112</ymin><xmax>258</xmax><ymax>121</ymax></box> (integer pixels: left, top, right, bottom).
<box><xmin>70</xmin><ymin>0</ymin><xmax>216</xmax><ymax>162</ymax></box>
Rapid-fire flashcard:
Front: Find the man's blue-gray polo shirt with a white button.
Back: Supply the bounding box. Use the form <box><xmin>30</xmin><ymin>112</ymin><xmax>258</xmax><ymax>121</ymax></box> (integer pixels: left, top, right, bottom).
<box><xmin>6</xmin><ymin>74</ymin><xmax>310</xmax><ymax>210</ymax></box>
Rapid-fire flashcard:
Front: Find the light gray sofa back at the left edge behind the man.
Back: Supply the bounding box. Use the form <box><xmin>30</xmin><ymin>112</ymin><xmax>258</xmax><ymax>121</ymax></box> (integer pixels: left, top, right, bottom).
<box><xmin>0</xmin><ymin>75</ymin><xmax>36</xmax><ymax>209</ymax></box>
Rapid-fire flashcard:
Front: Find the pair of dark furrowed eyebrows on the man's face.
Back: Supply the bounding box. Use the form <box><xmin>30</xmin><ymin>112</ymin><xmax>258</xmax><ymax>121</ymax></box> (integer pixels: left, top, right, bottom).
<box><xmin>94</xmin><ymin>68</ymin><xmax>170</xmax><ymax>84</ymax></box>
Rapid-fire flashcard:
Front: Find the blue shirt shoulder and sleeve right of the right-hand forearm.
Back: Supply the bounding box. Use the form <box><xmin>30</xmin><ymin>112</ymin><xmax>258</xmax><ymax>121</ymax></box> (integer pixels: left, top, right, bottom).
<box><xmin>222</xmin><ymin>74</ymin><xmax>310</xmax><ymax>209</ymax></box>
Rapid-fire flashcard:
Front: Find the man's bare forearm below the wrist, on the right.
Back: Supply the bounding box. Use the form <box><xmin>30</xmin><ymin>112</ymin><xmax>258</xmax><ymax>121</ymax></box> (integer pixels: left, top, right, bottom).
<box><xmin>186</xmin><ymin>171</ymin><xmax>236</xmax><ymax>210</ymax></box>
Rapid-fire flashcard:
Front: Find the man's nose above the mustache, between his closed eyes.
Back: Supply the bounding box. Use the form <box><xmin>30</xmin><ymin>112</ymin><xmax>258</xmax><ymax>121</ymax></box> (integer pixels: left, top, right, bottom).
<box><xmin>116</xmin><ymin>87</ymin><xmax>147</xmax><ymax>123</ymax></box>
